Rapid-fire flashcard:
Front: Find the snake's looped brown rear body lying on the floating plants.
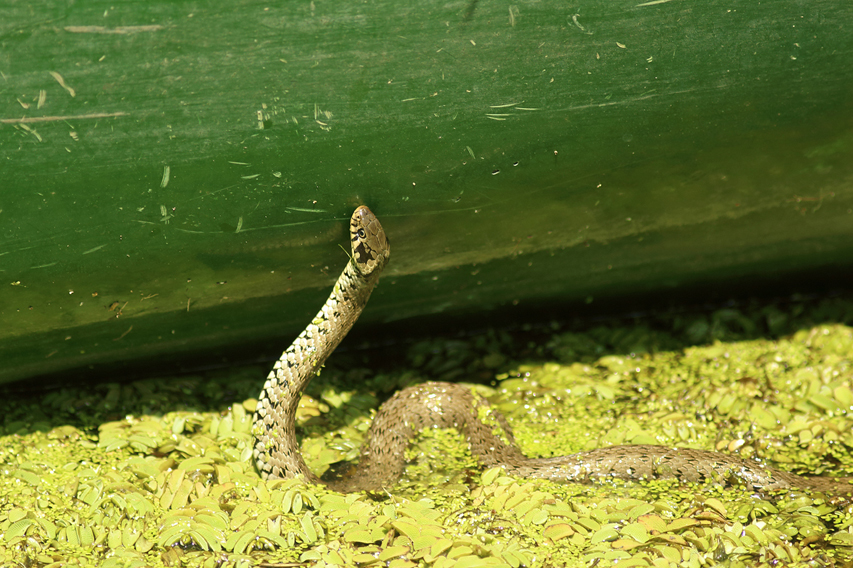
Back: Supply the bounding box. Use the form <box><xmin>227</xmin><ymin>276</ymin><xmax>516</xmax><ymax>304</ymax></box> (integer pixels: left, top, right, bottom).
<box><xmin>329</xmin><ymin>382</ymin><xmax>853</xmax><ymax>496</ymax></box>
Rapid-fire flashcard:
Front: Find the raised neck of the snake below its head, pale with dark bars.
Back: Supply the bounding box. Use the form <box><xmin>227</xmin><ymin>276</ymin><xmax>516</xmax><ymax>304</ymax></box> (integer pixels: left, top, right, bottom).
<box><xmin>248</xmin><ymin>260</ymin><xmax>379</xmax><ymax>482</ymax></box>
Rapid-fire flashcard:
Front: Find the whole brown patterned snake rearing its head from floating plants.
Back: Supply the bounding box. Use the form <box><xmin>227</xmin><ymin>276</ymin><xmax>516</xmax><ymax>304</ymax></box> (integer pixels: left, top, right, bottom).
<box><xmin>252</xmin><ymin>205</ymin><xmax>853</xmax><ymax>496</ymax></box>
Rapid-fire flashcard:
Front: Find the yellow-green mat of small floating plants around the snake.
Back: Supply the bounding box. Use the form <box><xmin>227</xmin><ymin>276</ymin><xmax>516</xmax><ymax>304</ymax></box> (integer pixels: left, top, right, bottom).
<box><xmin>0</xmin><ymin>301</ymin><xmax>853</xmax><ymax>568</ymax></box>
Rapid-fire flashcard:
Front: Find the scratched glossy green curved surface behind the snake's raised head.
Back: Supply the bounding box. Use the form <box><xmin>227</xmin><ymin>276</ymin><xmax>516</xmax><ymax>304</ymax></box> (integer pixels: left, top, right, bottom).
<box><xmin>0</xmin><ymin>0</ymin><xmax>853</xmax><ymax>381</ymax></box>
